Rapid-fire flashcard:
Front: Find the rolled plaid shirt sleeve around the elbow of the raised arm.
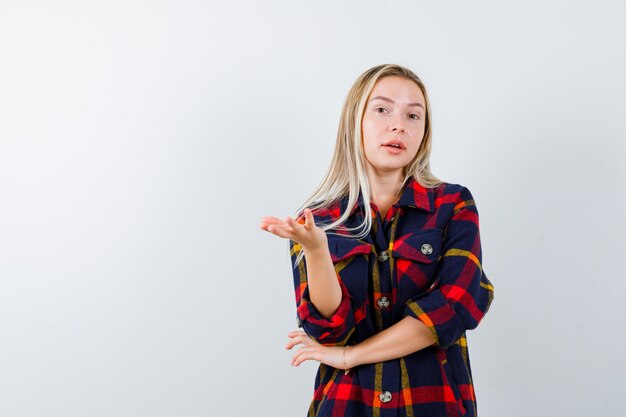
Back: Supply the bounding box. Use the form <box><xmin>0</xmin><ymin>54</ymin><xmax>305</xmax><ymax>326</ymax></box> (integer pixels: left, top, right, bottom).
<box><xmin>289</xmin><ymin>240</ymin><xmax>355</xmax><ymax>346</ymax></box>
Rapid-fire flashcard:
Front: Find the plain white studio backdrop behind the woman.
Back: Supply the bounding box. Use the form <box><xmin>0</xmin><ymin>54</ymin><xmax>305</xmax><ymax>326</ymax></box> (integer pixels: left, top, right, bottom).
<box><xmin>0</xmin><ymin>0</ymin><xmax>626</xmax><ymax>417</ymax></box>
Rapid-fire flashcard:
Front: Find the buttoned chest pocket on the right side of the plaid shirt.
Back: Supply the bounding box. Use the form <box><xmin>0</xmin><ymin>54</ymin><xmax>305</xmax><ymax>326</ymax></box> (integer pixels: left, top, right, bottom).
<box><xmin>392</xmin><ymin>228</ymin><xmax>443</xmax><ymax>298</ymax></box>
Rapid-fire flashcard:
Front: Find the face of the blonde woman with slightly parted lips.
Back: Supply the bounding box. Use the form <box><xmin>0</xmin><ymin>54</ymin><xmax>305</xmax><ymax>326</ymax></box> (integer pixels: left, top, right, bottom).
<box><xmin>361</xmin><ymin>76</ymin><xmax>426</xmax><ymax>175</ymax></box>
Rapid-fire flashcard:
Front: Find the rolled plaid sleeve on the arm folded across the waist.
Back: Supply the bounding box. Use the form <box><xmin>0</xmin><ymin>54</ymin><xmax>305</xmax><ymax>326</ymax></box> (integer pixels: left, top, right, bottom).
<box><xmin>404</xmin><ymin>187</ymin><xmax>494</xmax><ymax>349</ymax></box>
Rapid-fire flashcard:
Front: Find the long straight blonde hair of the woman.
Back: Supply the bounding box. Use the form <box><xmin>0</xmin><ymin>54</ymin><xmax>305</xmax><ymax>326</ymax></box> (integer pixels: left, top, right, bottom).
<box><xmin>293</xmin><ymin>64</ymin><xmax>442</xmax><ymax>265</ymax></box>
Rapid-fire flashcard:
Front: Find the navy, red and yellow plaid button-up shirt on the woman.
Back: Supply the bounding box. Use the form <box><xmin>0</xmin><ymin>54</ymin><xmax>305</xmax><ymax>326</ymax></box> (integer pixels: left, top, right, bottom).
<box><xmin>290</xmin><ymin>179</ymin><xmax>493</xmax><ymax>417</ymax></box>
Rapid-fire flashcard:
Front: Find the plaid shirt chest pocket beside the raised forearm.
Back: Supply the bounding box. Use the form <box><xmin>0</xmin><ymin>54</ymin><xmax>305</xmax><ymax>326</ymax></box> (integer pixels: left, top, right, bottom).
<box><xmin>328</xmin><ymin>235</ymin><xmax>372</xmax><ymax>308</ymax></box>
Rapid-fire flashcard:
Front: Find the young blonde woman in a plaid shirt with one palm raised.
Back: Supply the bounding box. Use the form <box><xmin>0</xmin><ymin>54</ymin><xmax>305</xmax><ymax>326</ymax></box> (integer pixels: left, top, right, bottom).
<box><xmin>261</xmin><ymin>65</ymin><xmax>494</xmax><ymax>417</ymax></box>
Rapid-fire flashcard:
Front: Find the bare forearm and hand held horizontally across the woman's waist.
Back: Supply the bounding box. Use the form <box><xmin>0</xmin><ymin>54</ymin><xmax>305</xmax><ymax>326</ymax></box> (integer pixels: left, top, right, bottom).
<box><xmin>286</xmin><ymin>317</ymin><xmax>435</xmax><ymax>369</ymax></box>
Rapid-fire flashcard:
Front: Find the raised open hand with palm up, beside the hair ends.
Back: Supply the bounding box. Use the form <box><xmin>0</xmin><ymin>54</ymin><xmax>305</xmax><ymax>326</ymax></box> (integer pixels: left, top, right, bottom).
<box><xmin>260</xmin><ymin>208</ymin><xmax>328</xmax><ymax>252</ymax></box>
